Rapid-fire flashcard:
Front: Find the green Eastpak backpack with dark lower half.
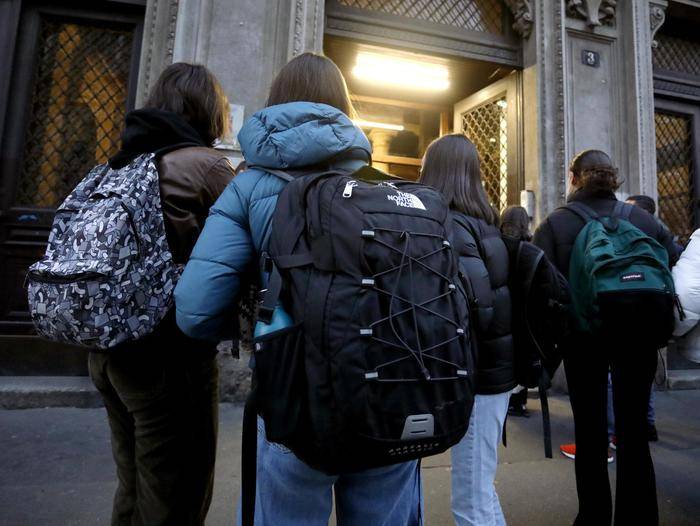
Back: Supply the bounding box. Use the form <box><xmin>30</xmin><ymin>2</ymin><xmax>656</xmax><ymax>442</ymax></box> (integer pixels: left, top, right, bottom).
<box><xmin>565</xmin><ymin>201</ymin><xmax>676</xmax><ymax>348</ymax></box>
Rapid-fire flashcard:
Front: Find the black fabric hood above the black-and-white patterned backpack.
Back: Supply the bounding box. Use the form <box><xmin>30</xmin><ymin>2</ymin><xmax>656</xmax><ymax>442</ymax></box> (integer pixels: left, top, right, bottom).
<box><xmin>109</xmin><ymin>108</ymin><xmax>209</xmax><ymax>168</ymax></box>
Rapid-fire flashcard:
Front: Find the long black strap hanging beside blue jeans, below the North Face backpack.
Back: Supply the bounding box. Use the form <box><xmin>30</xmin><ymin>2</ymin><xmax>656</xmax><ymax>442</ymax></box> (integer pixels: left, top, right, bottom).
<box><xmin>243</xmin><ymin>388</ymin><xmax>258</xmax><ymax>526</ymax></box>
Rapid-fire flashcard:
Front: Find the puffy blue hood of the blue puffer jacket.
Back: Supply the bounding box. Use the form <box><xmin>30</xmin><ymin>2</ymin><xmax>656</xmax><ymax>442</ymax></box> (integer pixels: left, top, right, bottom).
<box><xmin>238</xmin><ymin>102</ymin><xmax>372</xmax><ymax>169</ymax></box>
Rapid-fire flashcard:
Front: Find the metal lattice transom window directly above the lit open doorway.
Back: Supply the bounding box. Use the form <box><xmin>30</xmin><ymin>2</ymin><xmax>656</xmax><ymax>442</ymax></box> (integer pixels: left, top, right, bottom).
<box><xmin>338</xmin><ymin>0</ymin><xmax>504</xmax><ymax>35</ymax></box>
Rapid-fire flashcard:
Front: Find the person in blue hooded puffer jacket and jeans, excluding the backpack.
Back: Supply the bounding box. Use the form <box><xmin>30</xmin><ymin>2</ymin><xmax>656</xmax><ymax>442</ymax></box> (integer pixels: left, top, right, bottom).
<box><xmin>175</xmin><ymin>53</ymin><xmax>421</xmax><ymax>526</ymax></box>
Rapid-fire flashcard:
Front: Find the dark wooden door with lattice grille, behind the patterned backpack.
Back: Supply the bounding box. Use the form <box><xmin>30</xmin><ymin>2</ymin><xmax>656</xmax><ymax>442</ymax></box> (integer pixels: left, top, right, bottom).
<box><xmin>0</xmin><ymin>0</ymin><xmax>145</xmax><ymax>335</ymax></box>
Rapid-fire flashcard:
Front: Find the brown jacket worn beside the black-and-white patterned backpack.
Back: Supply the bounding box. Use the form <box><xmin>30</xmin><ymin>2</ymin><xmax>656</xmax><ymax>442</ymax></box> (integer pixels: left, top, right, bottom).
<box><xmin>158</xmin><ymin>147</ymin><xmax>233</xmax><ymax>263</ymax></box>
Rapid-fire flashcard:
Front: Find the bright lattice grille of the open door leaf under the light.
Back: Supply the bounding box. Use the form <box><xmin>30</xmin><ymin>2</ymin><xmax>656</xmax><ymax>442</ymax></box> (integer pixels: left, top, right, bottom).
<box><xmin>462</xmin><ymin>97</ymin><xmax>508</xmax><ymax>210</ymax></box>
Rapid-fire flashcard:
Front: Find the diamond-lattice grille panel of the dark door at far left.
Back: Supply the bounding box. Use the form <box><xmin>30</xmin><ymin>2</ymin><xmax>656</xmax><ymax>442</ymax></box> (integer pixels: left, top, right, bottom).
<box><xmin>16</xmin><ymin>17</ymin><xmax>133</xmax><ymax>208</ymax></box>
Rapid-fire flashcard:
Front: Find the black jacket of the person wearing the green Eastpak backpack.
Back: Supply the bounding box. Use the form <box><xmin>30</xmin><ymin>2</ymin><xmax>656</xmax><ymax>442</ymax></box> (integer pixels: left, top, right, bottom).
<box><xmin>533</xmin><ymin>189</ymin><xmax>677</xmax><ymax>278</ymax></box>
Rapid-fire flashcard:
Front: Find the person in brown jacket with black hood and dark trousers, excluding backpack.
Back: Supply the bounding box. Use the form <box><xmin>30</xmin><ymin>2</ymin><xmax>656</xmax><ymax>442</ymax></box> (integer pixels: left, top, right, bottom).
<box><xmin>89</xmin><ymin>63</ymin><xmax>233</xmax><ymax>526</ymax></box>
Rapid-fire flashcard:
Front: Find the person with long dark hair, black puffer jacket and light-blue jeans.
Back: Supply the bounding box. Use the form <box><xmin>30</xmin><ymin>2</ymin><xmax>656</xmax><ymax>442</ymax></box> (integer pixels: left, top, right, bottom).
<box><xmin>420</xmin><ymin>134</ymin><xmax>515</xmax><ymax>526</ymax></box>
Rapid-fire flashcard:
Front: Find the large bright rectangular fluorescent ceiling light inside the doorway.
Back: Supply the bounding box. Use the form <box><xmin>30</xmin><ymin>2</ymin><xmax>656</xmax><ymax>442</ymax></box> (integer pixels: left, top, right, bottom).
<box><xmin>352</xmin><ymin>51</ymin><xmax>450</xmax><ymax>91</ymax></box>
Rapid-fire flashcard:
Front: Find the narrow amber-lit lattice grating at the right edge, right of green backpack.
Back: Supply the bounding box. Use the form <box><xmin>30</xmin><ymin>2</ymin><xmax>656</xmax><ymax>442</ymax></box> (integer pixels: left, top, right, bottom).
<box><xmin>654</xmin><ymin>110</ymin><xmax>697</xmax><ymax>242</ymax></box>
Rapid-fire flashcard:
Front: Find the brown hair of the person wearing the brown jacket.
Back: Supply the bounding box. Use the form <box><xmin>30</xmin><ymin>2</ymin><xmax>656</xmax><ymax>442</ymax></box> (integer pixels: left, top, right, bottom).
<box><xmin>144</xmin><ymin>62</ymin><xmax>229</xmax><ymax>145</ymax></box>
